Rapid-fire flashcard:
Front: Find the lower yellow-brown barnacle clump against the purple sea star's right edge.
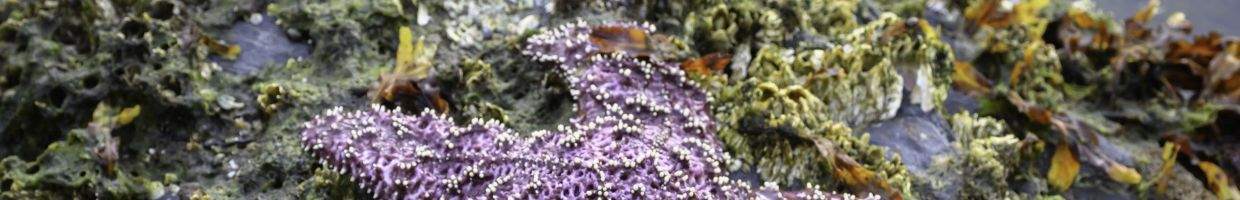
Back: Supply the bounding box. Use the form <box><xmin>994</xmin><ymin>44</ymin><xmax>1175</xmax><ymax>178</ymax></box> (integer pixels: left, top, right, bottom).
<box><xmin>719</xmin><ymin>82</ymin><xmax>909</xmax><ymax>196</ymax></box>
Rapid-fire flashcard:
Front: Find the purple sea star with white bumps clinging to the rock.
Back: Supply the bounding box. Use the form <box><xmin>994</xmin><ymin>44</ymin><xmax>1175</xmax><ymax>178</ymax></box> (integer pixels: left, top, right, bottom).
<box><xmin>303</xmin><ymin>22</ymin><xmax>872</xmax><ymax>199</ymax></box>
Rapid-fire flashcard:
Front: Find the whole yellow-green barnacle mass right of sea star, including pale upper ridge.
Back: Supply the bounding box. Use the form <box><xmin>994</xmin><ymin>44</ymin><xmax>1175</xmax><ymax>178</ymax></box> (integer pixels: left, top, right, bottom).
<box><xmin>688</xmin><ymin>6</ymin><xmax>952</xmax><ymax>199</ymax></box>
